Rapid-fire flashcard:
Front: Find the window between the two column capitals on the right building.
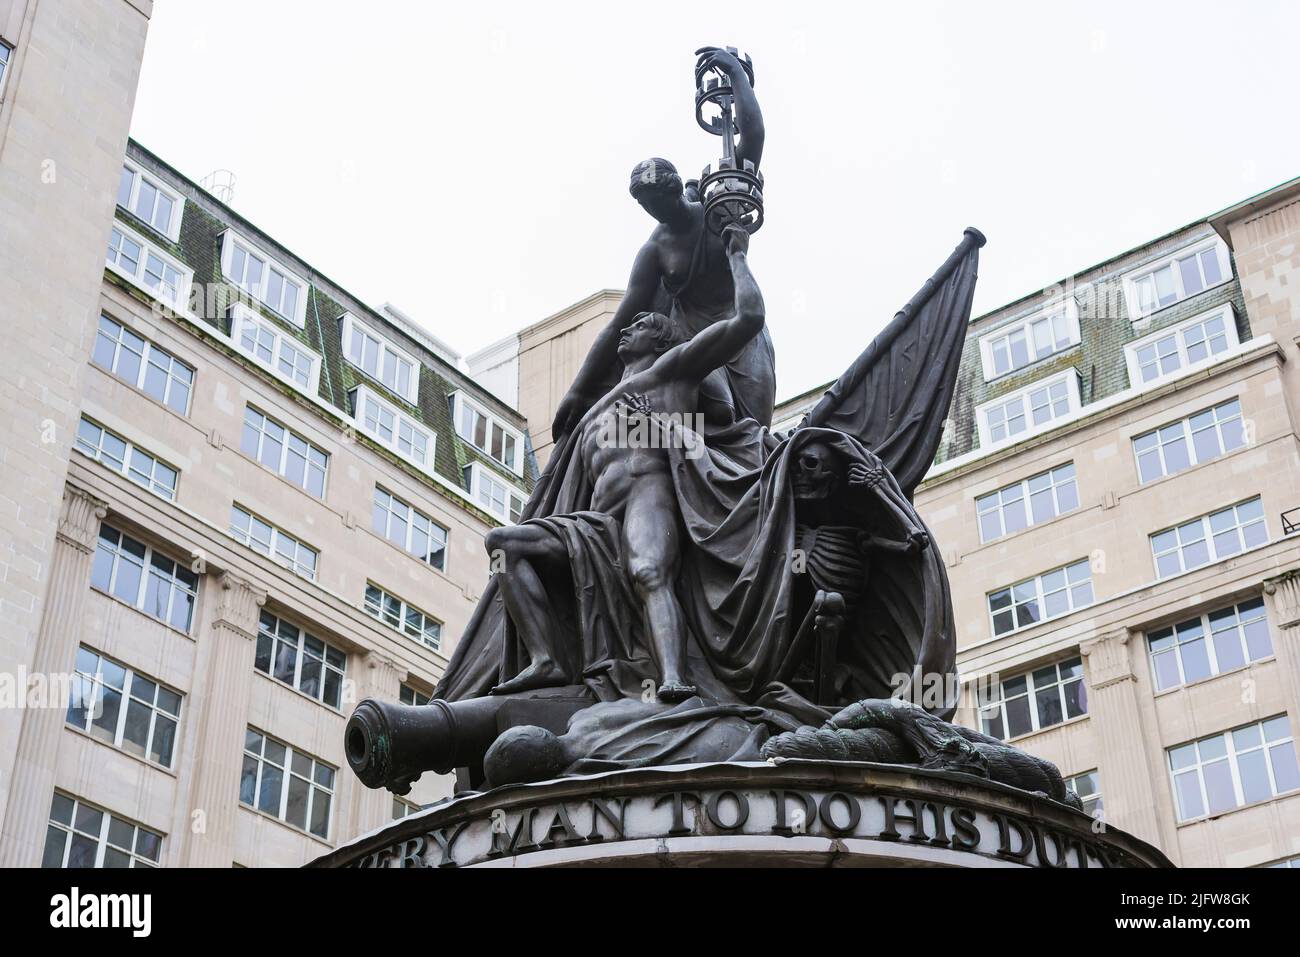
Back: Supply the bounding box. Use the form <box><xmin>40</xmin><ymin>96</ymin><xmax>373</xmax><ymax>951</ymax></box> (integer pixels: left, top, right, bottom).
<box><xmin>1147</xmin><ymin>598</ymin><xmax>1273</xmax><ymax>692</ymax></box>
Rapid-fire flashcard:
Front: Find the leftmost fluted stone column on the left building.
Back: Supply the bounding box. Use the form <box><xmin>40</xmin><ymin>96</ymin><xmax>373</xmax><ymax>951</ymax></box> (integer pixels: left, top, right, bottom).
<box><xmin>0</xmin><ymin>485</ymin><xmax>108</xmax><ymax>867</ymax></box>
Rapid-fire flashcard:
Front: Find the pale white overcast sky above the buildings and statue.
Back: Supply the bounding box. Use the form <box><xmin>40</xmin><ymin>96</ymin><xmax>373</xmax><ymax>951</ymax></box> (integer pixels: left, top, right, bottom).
<box><xmin>131</xmin><ymin>0</ymin><xmax>1300</xmax><ymax>397</ymax></box>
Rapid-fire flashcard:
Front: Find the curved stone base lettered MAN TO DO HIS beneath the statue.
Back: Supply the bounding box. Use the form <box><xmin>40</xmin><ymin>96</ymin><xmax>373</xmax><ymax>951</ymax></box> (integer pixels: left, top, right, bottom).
<box><xmin>308</xmin><ymin>759</ymin><xmax>1171</xmax><ymax>869</ymax></box>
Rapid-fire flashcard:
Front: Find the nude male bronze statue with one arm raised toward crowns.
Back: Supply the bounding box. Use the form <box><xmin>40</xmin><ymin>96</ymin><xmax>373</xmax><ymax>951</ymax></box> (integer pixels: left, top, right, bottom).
<box><xmin>485</xmin><ymin>226</ymin><xmax>764</xmax><ymax>702</ymax></box>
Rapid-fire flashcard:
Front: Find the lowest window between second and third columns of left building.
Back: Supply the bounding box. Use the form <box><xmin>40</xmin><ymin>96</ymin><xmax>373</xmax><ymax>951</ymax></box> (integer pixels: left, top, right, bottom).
<box><xmin>239</xmin><ymin>728</ymin><xmax>334</xmax><ymax>840</ymax></box>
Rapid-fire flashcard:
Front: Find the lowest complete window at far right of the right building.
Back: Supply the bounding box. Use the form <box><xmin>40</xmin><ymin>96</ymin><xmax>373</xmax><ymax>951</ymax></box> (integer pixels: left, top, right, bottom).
<box><xmin>1169</xmin><ymin>714</ymin><xmax>1300</xmax><ymax>820</ymax></box>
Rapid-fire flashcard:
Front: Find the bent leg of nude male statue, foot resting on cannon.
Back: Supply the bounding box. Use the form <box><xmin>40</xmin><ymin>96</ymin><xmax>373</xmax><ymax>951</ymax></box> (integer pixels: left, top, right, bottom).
<box><xmin>485</xmin><ymin>525</ymin><xmax>569</xmax><ymax>694</ymax></box>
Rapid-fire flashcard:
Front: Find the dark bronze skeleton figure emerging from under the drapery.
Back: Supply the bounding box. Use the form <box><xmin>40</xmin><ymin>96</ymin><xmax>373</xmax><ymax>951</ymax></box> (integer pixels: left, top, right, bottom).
<box><xmin>790</xmin><ymin>442</ymin><xmax>930</xmax><ymax>703</ymax></box>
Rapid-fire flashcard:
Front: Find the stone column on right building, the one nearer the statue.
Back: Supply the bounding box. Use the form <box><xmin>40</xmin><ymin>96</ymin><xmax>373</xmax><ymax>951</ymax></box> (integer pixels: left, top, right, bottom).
<box><xmin>1079</xmin><ymin>628</ymin><xmax>1161</xmax><ymax>846</ymax></box>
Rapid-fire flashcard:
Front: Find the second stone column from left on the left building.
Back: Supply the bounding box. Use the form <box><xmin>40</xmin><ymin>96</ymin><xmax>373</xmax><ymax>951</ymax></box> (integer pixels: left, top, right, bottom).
<box><xmin>181</xmin><ymin>572</ymin><xmax>267</xmax><ymax>867</ymax></box>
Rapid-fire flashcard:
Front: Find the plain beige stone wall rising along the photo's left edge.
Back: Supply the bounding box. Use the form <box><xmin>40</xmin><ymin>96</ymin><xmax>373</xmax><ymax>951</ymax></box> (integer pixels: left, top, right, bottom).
<box><xmin>0</xmin><ymin>0</ymin><xmax>151</xmax><ymax>833</ymax></box>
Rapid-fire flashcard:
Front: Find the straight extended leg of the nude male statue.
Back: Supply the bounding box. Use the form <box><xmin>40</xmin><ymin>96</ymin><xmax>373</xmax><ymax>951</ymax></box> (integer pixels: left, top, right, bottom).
<box><xmin>623</xmin><ymin>473</ymin><xmax>696</xmax><ymax>701</ymax></box>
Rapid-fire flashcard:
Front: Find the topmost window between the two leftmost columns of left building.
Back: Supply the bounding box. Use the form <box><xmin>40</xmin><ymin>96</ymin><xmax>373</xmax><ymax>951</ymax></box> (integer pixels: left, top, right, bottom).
<box><xmin>90</xmin><ymin>525</ymin><xmax>199</xmax><ymax>635</ymax></box>
